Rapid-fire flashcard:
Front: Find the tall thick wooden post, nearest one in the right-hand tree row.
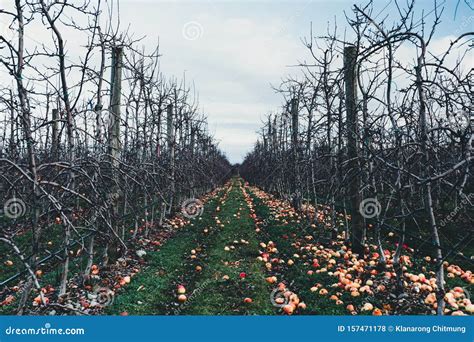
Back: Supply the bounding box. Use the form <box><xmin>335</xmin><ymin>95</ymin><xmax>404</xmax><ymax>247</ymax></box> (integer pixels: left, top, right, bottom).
<box><xmin>344</xmin><ymin>46</ymin><xmax>365</xmax><ymax>256</ymax></box>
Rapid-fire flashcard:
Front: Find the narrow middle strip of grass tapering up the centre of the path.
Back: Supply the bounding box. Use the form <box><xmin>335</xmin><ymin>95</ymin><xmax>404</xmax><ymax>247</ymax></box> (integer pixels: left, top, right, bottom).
<box><xmin>178</xmin><ymin>182</ymin><xmax>275</xmax><ymax>315</ymax></box>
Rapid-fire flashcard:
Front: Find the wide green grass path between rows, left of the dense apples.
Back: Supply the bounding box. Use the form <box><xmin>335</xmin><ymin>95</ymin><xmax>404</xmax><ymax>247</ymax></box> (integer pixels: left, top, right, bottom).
<box><xmin>107</xmin><ymin>180</ymin><xmax>276</xmax><ymax>315</ymax></box>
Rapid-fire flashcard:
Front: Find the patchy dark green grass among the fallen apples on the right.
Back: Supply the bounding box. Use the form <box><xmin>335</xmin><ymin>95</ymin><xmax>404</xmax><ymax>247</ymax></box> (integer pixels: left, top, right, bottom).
<box><xmin>251</xmin><ymin>193</ymin><xmax>474</xmax><ymax>315</ymax></box>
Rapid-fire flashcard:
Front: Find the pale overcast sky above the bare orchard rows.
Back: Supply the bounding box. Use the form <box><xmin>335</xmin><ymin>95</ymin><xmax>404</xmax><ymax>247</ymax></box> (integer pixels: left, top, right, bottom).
<box><xmin>0</xmin><ymin>0</ymin><xmax>474</xmax><ymax>163</ymax></box>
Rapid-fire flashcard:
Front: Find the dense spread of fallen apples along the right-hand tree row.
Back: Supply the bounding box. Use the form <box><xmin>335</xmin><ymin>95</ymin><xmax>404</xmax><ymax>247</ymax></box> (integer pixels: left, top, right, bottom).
<box><xmin>249</xmin><ymin>187</ymin><xmax>474</xmax><ymax>315</ymax></box>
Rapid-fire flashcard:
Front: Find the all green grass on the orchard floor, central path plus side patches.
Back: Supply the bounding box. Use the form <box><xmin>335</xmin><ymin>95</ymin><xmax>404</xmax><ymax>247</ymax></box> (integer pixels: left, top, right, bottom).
<box><xmin>0</xmin><ymin>178</ymin><xmax>474</xmax><ymax>315</ymax></box>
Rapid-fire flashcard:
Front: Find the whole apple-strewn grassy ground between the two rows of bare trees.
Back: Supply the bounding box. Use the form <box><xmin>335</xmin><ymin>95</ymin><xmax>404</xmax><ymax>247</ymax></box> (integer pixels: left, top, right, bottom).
<box><xmin>0</xmin><ymin>178</ymin><xmax>474</xmax><ymax>315</ymax></box>
